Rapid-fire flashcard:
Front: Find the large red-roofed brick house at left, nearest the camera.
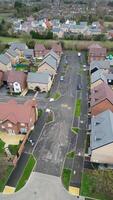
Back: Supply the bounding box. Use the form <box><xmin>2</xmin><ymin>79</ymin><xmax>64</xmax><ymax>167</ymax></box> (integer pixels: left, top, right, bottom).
<box><xmin>0</xmin><ymin>100</ymin><xmax>37</xmax><ymax>135</ymax></box>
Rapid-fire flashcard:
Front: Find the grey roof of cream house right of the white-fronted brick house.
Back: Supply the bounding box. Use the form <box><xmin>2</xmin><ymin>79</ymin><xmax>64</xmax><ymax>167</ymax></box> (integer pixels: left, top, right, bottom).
<box><xmin>27</xmin><ymin>72</ymin><xmax>50</xmax><ymax>84</ymax></box>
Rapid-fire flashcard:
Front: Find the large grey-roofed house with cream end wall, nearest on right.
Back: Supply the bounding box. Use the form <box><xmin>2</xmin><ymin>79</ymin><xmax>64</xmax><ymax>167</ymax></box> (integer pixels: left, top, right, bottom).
<box><xmin>90</xmin><ymin>110</ymin><xmax>113</xmax><ymax>164</ymax></box>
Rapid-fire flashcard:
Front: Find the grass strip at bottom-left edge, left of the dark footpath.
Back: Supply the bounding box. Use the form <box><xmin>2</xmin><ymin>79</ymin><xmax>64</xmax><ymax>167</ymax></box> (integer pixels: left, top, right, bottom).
<box><xmin>0</xmin><ymin>166</ymin><xmax>13</xmax><ymax>192</ymax></box>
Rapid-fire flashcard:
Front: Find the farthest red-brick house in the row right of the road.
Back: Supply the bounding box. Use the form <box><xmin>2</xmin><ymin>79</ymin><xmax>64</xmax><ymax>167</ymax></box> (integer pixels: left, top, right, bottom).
<box><xmin>88</xmin><ymin>44</ymin><xmax>107</xmax><ymax>63</ymax></box>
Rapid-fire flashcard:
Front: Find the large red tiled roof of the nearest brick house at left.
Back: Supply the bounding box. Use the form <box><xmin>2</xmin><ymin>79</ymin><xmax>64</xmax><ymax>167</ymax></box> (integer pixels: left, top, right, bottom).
<box><xmin>0</xmin><ymin>100</ymin><xmax>36</xmax><ymax>124</ymax></box>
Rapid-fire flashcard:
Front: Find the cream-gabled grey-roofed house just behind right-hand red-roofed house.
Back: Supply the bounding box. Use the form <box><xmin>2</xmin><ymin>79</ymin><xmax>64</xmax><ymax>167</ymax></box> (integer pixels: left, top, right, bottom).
<box><xmin>91</xmin><ymin>69</ymin><xmax>107</xmax><ymax>89</ymax></box>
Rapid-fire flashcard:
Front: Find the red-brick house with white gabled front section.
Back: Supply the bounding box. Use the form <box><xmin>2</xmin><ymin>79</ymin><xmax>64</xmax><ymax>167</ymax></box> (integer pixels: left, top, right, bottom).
<box><xmin>7</xmin><ymin>70</ymin><xmax>27</xmax><ymax>93</ymax></box>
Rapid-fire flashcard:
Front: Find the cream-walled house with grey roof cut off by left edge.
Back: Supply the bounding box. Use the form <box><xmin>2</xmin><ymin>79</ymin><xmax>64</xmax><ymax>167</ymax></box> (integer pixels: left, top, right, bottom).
<box><xmin>0</xmin><ymin>54</ymin><xmax>12</xmax><ymax>72</ymax></box>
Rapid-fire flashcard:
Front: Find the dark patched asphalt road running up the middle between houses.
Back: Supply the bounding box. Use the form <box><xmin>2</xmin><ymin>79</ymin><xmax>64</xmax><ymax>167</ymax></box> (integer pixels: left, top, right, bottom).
<box><xmin>34</xmin><ymin>52</ymin><xmax>80</xmax><ymax>176</ymax></box>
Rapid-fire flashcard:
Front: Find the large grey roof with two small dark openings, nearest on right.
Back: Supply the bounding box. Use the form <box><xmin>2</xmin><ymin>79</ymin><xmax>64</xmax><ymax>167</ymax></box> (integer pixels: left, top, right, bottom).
<box><xmin>90</xmin><ymin>110</ymin><xmax>113</xmax><ymax>150</ymax></box>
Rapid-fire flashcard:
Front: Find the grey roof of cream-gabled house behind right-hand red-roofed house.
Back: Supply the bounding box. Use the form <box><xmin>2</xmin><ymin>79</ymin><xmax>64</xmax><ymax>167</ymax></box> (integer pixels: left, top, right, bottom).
<box><xmin>91</xmin><ymin>69</ymin><xmax>107</xmax><ymax>83</ymax></box>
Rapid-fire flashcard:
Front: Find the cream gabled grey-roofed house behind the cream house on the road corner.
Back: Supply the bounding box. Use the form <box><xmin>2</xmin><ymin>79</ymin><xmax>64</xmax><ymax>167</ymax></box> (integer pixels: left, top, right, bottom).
<box><xmin>38</xmin><ymin>56</ymin><xmax>58</xmax><ymax>77</ymax></box>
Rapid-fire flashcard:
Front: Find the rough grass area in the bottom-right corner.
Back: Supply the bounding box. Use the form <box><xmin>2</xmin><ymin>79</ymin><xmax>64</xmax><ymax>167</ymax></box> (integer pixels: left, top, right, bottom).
<box><xmin>81</xmin><ymin>169</ymin><xmax>113</xmax><ymax>200</ymax></box>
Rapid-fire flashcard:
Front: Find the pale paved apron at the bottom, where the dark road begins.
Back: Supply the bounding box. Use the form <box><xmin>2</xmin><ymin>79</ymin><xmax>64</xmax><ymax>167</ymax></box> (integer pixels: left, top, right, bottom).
<box><xmin>0</xmin><ymin>172</ymin><xmax>84</xmax><ymax>200</ymax></box>
